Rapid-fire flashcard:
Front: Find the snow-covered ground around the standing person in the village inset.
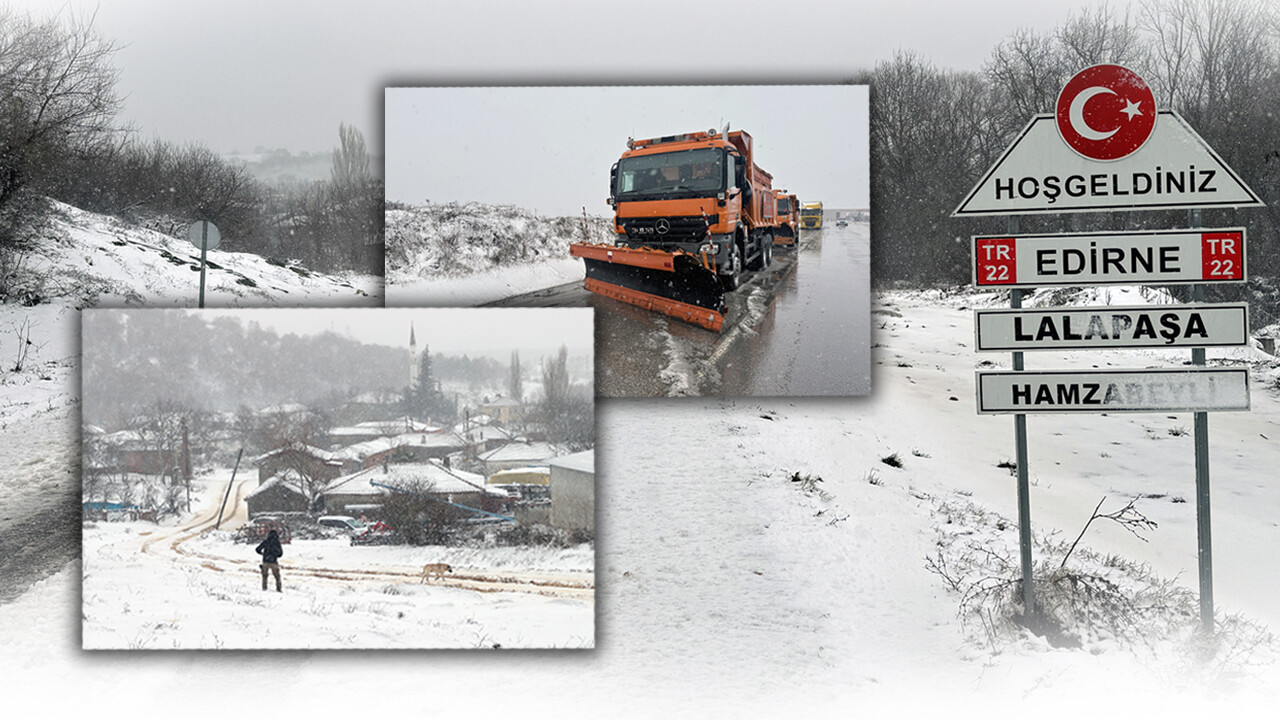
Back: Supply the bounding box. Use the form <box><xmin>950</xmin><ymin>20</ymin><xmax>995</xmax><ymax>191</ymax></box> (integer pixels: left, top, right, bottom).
<box><xmin>82</xmin><ymin>468</ymin><xmax>594</xmax><ymax>650</ymax></box>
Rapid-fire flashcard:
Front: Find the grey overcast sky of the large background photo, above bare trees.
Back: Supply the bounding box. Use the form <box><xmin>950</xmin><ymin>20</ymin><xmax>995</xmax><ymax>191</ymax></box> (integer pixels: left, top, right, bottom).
<box><xmin>10</xmin><ymin>0</ymin><xmax>1105</xmax><ymax>155</ymax></box>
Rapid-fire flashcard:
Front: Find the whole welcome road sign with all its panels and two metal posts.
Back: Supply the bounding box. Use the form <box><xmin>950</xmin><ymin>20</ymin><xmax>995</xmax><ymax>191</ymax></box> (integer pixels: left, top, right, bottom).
<box><xmin>951</xmin><ymin>64</ymin><xmax>1265</xmax><ymax>633</ymax></box>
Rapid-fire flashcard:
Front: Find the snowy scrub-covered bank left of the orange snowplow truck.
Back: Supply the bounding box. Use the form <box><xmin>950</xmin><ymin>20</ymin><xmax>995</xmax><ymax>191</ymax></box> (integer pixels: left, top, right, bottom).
<box><xmin>385</xmin><ymin>202</ymin><xmax>613</xmax><ymax>306</ymax></box>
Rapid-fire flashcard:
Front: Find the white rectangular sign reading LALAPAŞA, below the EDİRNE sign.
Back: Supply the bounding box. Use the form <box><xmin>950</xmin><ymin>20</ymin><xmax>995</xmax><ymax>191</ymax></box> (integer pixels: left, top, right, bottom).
<box><xmin>974</xmin><ymin>302</ymin><xmax>1249</xmax><ymax>352</ymax></box>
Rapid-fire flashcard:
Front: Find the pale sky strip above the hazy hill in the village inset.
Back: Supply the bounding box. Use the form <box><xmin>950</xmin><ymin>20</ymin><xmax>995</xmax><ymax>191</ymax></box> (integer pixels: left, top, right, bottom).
<box><xmin>193</xmin><ymin>307</ymin><xmax>594</xmax><ymax>363</ymax></box>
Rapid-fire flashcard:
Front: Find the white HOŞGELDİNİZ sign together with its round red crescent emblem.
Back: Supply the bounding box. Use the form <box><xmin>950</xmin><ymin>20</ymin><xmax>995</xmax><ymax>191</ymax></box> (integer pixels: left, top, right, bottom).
<box><xmin>952</xmin><ymin>65</ymin><xmax>1263</xmax><ymax>217</ymax></box>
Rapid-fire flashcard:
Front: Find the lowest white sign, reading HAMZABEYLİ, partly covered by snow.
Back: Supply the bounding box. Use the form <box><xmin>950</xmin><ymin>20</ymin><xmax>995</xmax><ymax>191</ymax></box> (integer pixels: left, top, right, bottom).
<box><xmin>977</xmin><ymin>368</ymin><xmax>1249</xmax><ymax>415</ymax></box>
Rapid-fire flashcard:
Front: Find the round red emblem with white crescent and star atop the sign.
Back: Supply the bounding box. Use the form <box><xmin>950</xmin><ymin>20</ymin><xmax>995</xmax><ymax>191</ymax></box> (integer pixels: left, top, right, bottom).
<box><xmin>1057</xmin><ymin>65</ymin><xmax>1156</xmax><ymax>160</ymax></box>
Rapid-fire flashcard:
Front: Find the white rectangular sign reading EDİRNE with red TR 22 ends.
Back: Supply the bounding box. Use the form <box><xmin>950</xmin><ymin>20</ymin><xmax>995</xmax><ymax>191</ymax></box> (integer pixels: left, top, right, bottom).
<box><xmin>973</xmin><ymin>228</ymin><xmax>1247</xmax><ymax>287</ymax></box>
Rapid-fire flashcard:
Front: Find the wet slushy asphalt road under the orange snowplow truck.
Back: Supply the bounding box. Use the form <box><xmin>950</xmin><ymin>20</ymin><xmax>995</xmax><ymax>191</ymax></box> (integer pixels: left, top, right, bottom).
<box><xmin>495</xmin><ymin>223</ymin><xmax>870</xmax><ymax>397</ymax></box>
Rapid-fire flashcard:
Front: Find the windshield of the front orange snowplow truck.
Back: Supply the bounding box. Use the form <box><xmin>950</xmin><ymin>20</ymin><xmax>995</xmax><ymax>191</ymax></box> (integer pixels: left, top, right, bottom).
<box><xmin>614</xmin><ymin>147</ymin><xmax>724</xmax><ymax>200</ymax></box>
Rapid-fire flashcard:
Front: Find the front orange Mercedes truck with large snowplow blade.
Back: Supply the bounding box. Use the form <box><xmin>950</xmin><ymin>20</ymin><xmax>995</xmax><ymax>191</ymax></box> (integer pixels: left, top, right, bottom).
<box><xmin>570</xmin><ymin>129</ymin><xmax>778</xmax><ymax>332</ymax></box>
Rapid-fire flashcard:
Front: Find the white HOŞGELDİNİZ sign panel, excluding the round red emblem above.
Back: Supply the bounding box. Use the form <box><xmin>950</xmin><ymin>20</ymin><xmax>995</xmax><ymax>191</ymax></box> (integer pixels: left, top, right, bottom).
<box><xmin>952</xmin><ymin>110</ymin><xmax>1263</xmax><ymax>217</ymax></box>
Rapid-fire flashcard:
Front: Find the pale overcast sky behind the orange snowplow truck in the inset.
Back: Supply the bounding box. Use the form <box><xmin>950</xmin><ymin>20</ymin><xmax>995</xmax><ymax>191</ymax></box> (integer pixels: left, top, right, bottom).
<box><xmin>385</xmin><ymin>85</ymin><xmax>870</xmax><ymax>215</ymax></box>
